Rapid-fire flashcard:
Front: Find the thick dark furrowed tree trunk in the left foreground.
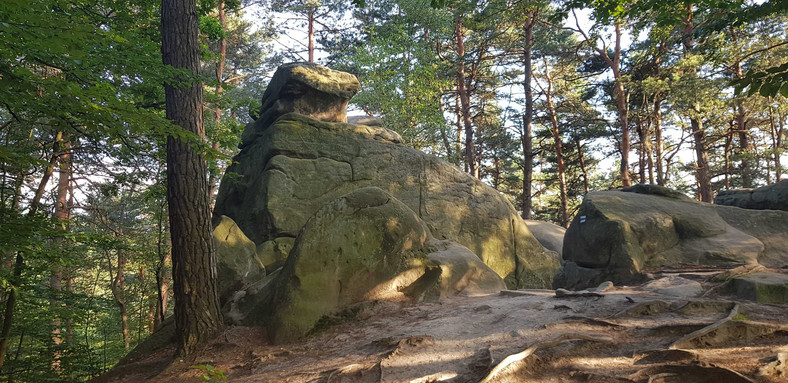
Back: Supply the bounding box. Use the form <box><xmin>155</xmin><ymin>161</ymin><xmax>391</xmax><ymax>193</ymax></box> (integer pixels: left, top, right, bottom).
<box><xmin>161</xmin><ymin>0</ymin><xmax>222</xmax><ymax>356</ymax></box>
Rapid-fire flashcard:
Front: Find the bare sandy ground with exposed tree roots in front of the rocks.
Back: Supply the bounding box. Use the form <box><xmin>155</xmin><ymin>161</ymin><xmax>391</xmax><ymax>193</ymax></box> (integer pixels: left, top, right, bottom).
<box><xmin>97</xmin><ymin>278</ymin><xmax>788</xmax><ymax>383</ymax></box>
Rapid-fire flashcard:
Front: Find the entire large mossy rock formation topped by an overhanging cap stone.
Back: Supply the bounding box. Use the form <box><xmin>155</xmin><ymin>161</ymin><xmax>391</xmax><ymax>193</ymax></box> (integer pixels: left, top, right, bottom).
<box><xmin>209</xmin><ymin>64</ymin><xmax>559</xmax><ymax>342</ymax></box>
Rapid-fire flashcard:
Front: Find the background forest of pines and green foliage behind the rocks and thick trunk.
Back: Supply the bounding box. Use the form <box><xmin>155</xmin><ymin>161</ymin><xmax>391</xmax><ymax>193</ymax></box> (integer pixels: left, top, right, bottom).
<box><xmin>0</xmin><ymin>0</ymin><xmax>788</xmax><ymax>381</ymax></box>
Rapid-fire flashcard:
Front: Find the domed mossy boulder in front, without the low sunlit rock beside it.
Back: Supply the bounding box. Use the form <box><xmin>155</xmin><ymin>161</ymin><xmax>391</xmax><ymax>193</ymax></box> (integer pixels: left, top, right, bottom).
<box><xmin>266</xmin><ymin>187</ymin><xmax>435</xmax><ymax>343</ymax></box>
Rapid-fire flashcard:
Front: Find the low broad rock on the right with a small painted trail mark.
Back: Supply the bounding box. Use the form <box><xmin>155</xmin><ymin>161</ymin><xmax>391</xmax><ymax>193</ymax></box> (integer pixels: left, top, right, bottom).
<box><xmin>554</xmin><ymin>186</ymin><xmax>788</xmax><ymax>288</ymax></box>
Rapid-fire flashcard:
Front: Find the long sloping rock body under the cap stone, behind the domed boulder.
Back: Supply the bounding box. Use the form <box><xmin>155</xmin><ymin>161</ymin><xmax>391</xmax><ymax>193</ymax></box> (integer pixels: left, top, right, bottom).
<box><xmin>214</xmin><ymin>63</ymin><xmax>558</xmax><ymax>287</ymax></box>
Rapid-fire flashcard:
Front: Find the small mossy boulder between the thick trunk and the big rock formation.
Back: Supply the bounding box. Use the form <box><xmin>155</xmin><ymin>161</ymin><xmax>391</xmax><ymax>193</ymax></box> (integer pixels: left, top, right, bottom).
<box><xmin>213</xmin><ymin>216</ymin><xmax>265</xmax><ymax>302</ymax></box>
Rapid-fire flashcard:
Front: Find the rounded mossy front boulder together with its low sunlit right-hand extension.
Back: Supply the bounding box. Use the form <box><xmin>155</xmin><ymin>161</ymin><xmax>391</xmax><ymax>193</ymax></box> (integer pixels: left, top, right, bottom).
<box><xmin>258</xmin><ymin>187</ymin><xmax>505</xmax><ymax>343</ymax></box>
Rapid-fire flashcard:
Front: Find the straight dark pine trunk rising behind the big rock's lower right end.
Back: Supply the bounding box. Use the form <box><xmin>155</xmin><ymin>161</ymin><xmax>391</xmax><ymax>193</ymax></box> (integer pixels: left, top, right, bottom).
<box><xmin>520</xmin><ymin>10</ymin><xmax>537</xmax><ymax>219</ymax></box>
